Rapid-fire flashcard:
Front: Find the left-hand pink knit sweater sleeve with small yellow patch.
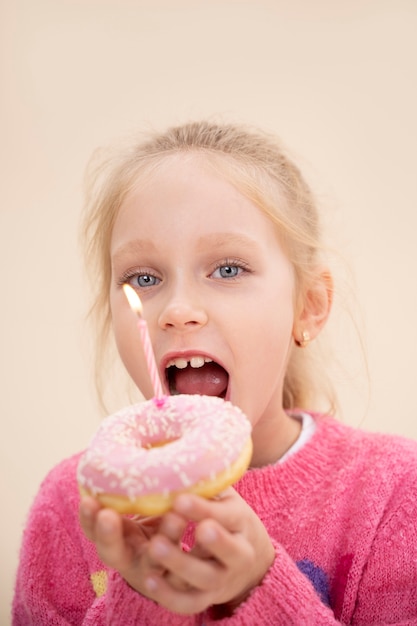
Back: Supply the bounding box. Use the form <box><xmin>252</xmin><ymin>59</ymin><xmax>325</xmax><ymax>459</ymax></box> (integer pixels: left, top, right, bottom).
<box><xmin>12</xmin><ymin>459</ymin><xmax>196</xmax><ymax>626</ymax></box>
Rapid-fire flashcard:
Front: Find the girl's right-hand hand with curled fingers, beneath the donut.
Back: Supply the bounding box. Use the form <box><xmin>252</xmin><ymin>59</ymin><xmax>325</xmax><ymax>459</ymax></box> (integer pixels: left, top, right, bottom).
<box><xmin>146</xmin><ymin>488</ymin><xmax>275</xmax><ymax>614</ymax></box>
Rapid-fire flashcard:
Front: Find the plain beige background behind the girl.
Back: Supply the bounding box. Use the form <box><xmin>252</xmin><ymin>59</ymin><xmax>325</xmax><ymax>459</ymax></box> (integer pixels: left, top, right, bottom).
<box><xmin>0</xmin><ymin>0</ymin><xmax>417</xmax><ymax>625</ymax></box>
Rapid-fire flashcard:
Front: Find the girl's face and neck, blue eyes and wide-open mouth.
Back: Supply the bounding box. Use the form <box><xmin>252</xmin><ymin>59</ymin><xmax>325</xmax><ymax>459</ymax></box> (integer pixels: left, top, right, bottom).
<box><xmin>110</xmin><ymin>157</ymin><xmax>298</xmax><ymax>463</ymax></box>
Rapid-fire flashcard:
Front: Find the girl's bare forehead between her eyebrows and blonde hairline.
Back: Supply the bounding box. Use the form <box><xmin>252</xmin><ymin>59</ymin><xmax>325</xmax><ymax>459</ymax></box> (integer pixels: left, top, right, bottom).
<box><xmin>112</xmin><ymin>154</ymin><xmax>280</xmax><ymax>245</ymax></box>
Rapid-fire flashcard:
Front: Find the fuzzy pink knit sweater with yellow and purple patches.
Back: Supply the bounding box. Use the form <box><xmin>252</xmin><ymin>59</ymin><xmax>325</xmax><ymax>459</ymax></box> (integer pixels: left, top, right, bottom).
<box><xmin>13</xmin><ymin>418</ymin><xmax>417</xmax><ymax>626</ymax></box>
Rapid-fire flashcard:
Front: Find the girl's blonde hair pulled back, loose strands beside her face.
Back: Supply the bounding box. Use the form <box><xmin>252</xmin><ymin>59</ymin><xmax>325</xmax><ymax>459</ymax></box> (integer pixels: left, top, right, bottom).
<box><xmin>82</xmin><ymin>121</ymin><xmax>335</xmax><ymax>409</ymax></box>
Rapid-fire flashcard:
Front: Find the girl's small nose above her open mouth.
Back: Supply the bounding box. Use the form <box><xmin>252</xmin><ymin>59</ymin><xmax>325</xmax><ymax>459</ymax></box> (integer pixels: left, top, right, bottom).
<box><xmin>158</xmin><ymin>294</ymin><xmax>208</xmax><ymax>331</ymax></box>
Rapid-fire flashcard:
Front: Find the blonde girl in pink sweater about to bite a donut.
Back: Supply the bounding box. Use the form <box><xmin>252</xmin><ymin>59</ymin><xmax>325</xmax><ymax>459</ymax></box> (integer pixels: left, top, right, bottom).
<box><xmin>13</xmin><ymin>122</ymin><xmax>417</xmax><ymax>626</ymax></box>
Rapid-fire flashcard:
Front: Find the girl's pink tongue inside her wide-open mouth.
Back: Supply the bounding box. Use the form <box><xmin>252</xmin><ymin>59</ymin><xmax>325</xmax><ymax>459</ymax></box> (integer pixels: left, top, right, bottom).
<box><xmin>175</xmin><ymin>363</ymin><xmax>228</xmax><ymax>396</ymax></box>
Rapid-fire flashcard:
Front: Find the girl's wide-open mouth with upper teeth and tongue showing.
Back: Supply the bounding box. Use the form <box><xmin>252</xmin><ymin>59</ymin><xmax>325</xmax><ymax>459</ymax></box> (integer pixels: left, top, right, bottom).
<box><xmin>165</xmin><ymin>355</ymin><xmax>229</xmax><ymax>398</ymax></box>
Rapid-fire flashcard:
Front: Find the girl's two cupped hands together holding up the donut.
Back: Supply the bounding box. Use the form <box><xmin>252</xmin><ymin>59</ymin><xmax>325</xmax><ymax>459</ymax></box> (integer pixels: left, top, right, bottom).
<box><xmin>80</xmin><ymin>488</ymin><xmax>275</xmax><ymax>614</ymax></box>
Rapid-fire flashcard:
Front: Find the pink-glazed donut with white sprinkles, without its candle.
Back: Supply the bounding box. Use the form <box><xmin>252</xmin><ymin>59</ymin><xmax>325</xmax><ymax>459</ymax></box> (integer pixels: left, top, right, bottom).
<box><xmin>77</xmin><ymin>394</ymin><xmax>252</xmax><ymax>515</ymax></box>
